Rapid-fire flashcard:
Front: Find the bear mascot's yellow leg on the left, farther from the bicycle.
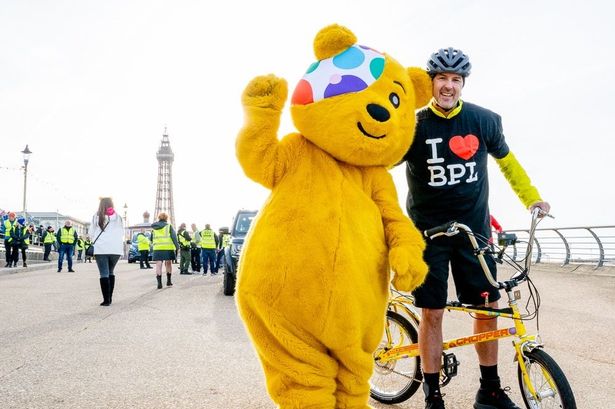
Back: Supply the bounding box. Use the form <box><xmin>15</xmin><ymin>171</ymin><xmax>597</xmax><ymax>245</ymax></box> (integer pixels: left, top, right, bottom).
<box><xmin>237</xmin><ymin>293</ymin><xmax>338</xmax><ymax>409</ymax></box>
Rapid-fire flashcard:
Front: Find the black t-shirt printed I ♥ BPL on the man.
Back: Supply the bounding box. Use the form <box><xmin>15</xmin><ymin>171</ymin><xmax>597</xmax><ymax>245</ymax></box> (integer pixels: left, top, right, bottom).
<box><xmin>404</xmin><ymin>102</ymin><xmax>509</xmax><ymax>235</ymax></box>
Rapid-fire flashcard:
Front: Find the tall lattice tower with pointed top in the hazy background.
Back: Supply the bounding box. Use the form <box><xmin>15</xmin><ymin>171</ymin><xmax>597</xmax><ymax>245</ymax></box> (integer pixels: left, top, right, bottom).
<box><xmin>154</xmin><ymin>127</ymin><xmax>175</xmax><ymax>226</ymax></box>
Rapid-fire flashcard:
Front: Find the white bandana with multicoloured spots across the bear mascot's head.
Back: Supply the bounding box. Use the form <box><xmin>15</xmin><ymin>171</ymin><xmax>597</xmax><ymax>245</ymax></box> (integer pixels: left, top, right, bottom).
<box><xmin>291</xmin><ymin>44</ymin><xmax>384</xmax><ymax>105</ymax></box>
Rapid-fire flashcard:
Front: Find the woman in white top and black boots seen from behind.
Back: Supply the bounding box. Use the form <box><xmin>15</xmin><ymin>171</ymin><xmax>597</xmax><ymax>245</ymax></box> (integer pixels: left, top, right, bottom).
<box><xmin>89</xmin><ymin>197</ymin><xmax>124</xmax><ymax>306</ymax></box>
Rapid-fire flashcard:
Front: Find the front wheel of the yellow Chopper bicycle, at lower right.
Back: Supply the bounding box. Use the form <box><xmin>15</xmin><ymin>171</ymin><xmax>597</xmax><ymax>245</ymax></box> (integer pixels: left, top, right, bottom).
<box><xmin>517</xmin><ymin>349</ymin><xmax>577</xmax><ymax>409</ymax></box>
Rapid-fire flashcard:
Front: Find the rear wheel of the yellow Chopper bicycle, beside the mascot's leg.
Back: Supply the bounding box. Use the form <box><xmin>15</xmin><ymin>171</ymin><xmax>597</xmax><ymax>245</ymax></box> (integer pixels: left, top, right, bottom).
<box><xmin>369</xmin><ymin>311</ymin><xmax>423</xmax><ymax>404</ymax></box>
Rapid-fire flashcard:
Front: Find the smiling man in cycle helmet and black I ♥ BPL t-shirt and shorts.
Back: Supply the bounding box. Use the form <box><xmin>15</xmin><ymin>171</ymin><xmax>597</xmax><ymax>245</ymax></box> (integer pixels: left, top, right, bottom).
<box><xmin>404</xmin><ymin>48</ymin><xmax>550</xmax><ymax>409</ymax></box>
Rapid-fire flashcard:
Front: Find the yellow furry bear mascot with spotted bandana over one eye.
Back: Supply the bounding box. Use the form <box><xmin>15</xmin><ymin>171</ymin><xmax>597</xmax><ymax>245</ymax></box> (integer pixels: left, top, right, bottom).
<box><xmin>236</xmin><ymin>25</ymin><xmax>431</xmax><ymax>408</ymax></box>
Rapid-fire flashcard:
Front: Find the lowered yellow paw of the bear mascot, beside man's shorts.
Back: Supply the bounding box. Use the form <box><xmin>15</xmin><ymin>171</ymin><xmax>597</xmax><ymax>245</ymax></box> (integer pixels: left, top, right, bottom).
<box><xmin>389</xmin><ymin>246</ymin><xmax>428</xmax><ymax>291</ymax></box>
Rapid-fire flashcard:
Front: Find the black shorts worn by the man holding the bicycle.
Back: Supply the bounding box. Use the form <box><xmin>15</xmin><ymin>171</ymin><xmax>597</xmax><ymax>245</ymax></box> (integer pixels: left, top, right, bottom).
<box><xmin>413</xmin><ymin>234</ymin><xmax>500</xmax><ymax>309</ymax></box>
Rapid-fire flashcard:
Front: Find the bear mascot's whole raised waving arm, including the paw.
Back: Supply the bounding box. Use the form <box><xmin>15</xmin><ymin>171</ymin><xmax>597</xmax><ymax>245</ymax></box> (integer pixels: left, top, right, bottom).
<box><xmin>235</xmin><ymin>75</ymin><xmax>288</xmax><ymax>189</ymax></box>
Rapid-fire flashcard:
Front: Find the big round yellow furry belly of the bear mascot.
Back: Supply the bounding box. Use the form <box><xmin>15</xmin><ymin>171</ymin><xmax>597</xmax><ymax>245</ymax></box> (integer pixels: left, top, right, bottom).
<box><xmin>237</xmin><ymin>158</ymin><xmax>389</xmax><ymax>341</ymax></box>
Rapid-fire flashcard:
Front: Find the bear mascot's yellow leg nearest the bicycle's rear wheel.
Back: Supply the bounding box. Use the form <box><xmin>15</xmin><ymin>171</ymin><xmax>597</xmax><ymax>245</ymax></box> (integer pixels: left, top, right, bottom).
<box><xmin>330</xmin><ymin>343</ymin><xmax>377</xmax><ymax>409</ymax></box>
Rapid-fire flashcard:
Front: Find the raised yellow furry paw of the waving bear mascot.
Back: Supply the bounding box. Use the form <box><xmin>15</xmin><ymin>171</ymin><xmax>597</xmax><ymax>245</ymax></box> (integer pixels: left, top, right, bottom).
<box><xmin>241</xmin><ymin>74</ymin><xmax>288</xmax><ymax>111</ymax></box>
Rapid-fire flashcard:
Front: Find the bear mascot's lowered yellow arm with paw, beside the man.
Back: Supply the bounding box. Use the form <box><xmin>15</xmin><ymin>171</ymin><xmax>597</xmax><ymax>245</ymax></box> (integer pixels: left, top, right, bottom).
<box><xmin>372</xmin><ymin>168</ymin><xmax>427</xmax><ymax>291</ymax></box>
